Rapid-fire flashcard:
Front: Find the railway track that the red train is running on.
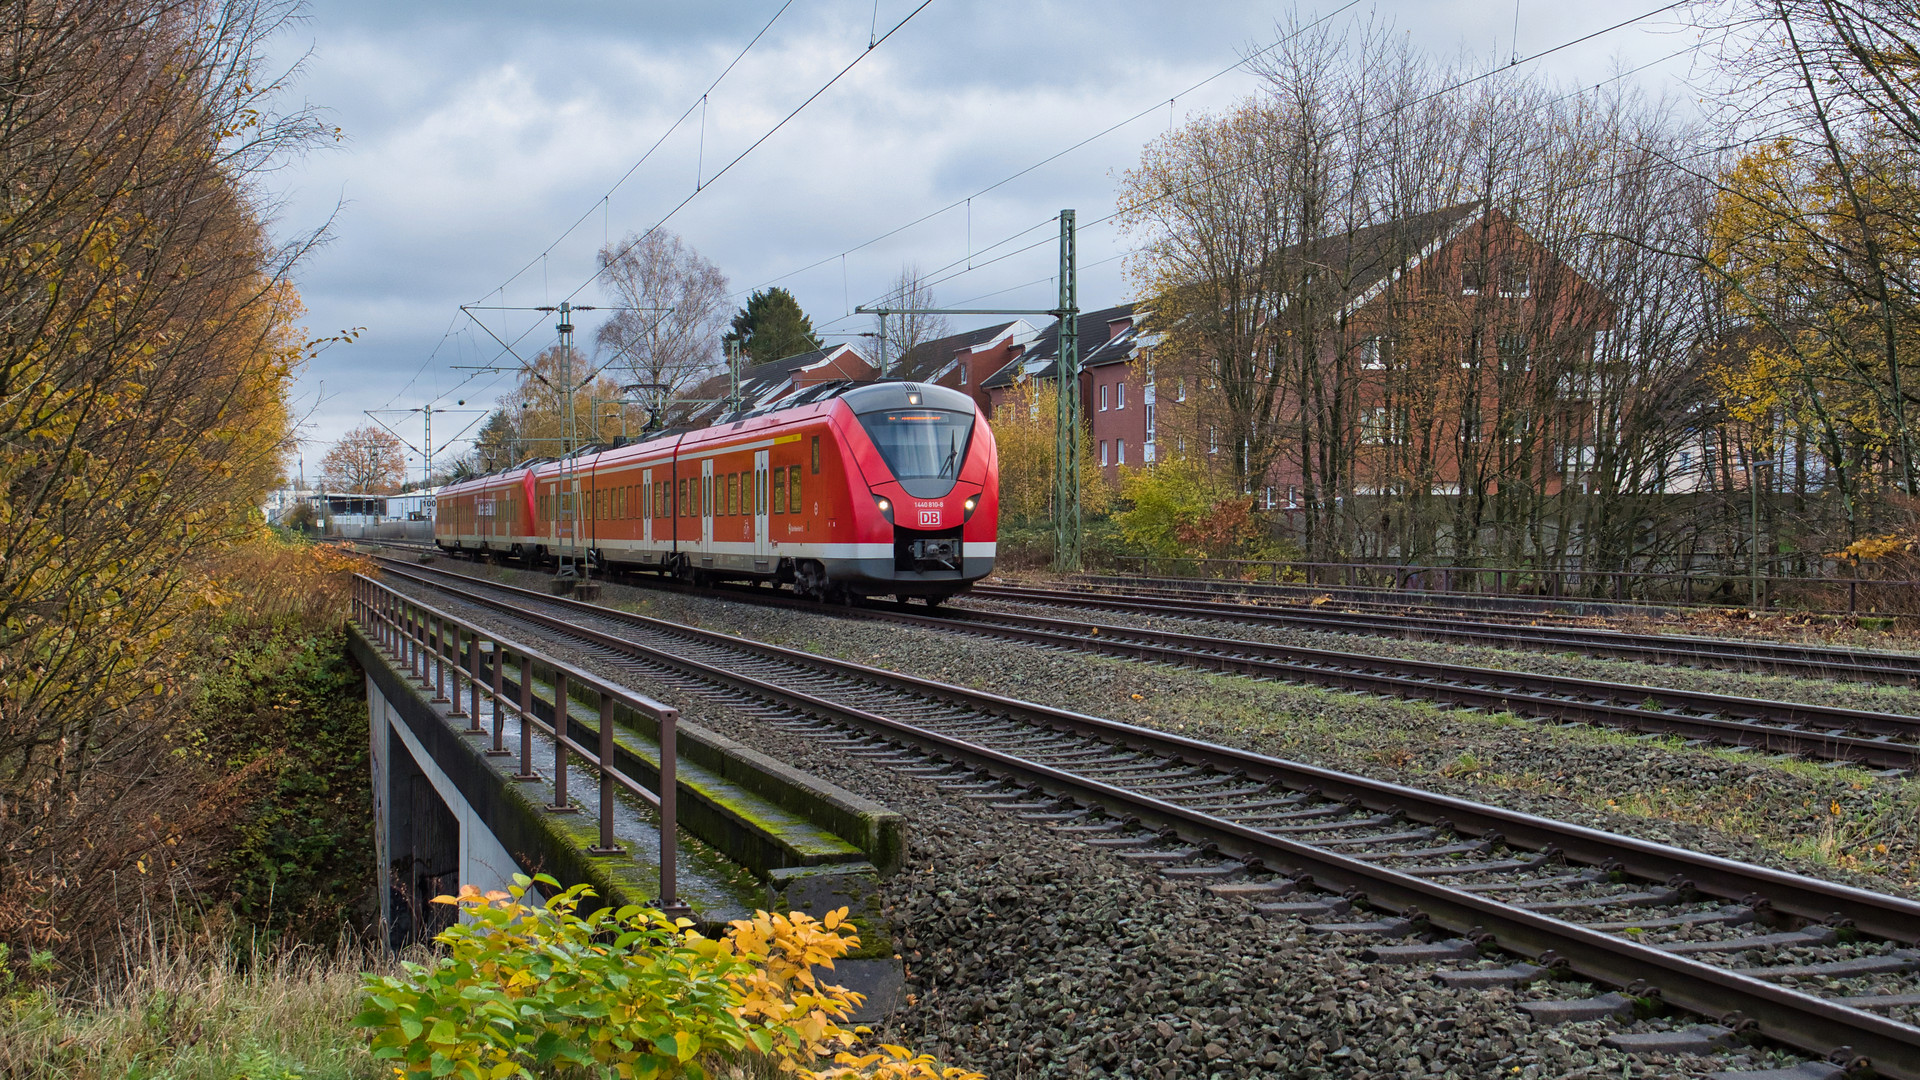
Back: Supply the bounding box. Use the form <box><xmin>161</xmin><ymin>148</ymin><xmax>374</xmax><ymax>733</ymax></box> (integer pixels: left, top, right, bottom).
<box><xmin>374</xmin><ymin>549</ymin><xmax>1920</xmax><ymax>773</ymax></box>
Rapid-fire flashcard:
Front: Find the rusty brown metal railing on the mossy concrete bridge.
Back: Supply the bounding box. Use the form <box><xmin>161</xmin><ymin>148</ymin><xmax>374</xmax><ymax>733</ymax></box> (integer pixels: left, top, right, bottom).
<box><xmin>353</xmin><ymin>575</ymin><xmax>687</xmax><ymax>915</ymax></box>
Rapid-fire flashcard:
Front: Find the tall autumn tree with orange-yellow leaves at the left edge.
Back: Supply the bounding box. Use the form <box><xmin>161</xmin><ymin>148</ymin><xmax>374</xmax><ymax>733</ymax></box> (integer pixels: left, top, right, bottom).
<box><xmin>0</xmin><ymin>0</ymin><xmax>323</xmax><ymax>945</ymax></box>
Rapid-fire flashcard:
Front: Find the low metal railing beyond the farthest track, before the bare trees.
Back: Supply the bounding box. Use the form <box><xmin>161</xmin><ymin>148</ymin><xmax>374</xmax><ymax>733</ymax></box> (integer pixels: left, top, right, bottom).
<box><xmin>1112</xmin><ymin>555</ymin><xmax>1920</xmax><ymax>615</ymax></box>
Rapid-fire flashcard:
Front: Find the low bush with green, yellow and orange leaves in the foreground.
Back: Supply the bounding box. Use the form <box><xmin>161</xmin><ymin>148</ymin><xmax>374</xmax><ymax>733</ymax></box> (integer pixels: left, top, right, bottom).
<box><xmin>357</xmin><ymin>874</ymin><xmax>979</xmax><ymax>1080</ymax></box>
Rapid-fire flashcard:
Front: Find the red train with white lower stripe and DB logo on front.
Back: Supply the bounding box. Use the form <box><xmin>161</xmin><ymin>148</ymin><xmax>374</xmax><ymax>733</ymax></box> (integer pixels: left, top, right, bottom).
<box><xmin>434</xmin><ymin>382</ymin><xmax>1000</xmax><ymax>605</ymax></box>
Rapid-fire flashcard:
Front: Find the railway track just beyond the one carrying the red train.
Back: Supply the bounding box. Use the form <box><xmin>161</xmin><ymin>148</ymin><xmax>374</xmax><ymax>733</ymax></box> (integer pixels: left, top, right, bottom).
<box><xmin>968</xmin><ymin>584</ymin><xmax>1920</xmax><ymax>684</ymax></box>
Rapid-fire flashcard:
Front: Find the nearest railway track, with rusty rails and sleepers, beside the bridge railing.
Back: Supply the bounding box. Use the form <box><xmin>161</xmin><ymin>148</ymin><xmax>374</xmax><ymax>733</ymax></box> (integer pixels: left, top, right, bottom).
<box><xmin>370</xmin><ymin>567</ymin><xmax>1920</xmax><ymax>1080</ymax></box>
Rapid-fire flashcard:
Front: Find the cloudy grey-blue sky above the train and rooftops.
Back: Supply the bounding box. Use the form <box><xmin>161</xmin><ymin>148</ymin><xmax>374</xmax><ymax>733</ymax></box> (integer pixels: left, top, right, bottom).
<box><xmin>273</xmin><ymin>0</ymin><xmax>1693</xmax><ymax>478</ymax></box>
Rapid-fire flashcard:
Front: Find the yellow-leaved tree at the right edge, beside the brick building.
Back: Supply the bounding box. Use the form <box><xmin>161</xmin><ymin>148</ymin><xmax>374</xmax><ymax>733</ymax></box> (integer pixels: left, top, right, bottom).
<box><xmin>1701</xmin><ymin>0</ymin><xmax>1920</xmax><ymax>542</ymax></box>
